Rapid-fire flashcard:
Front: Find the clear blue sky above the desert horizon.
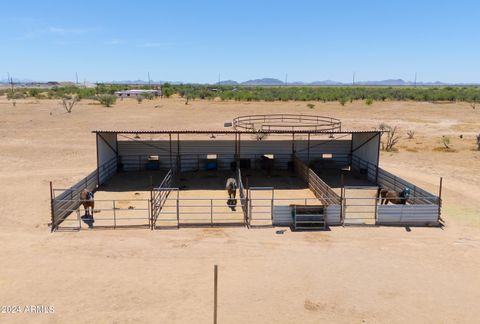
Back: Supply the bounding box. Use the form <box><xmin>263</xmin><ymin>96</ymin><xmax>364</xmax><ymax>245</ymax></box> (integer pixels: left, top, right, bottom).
<box><xmin>0</xmin><ymin>0</ymin><xmax>480</xmax><ymax>83</ymax></box>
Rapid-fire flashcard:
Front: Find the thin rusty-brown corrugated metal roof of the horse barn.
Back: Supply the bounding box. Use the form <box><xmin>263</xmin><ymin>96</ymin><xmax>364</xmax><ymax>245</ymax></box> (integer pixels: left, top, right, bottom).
<box><xmin>92</xmin><ymin>129</ymin><xmax>383</xmax><ymax>134</ymax></box>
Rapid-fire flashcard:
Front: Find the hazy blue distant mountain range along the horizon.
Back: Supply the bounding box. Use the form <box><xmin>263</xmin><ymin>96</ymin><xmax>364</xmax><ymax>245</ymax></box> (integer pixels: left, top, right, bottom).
<box><xmin>0</xmin><ymin>78</ymin><xmax>479</xmax><ymax>86</ymax></box>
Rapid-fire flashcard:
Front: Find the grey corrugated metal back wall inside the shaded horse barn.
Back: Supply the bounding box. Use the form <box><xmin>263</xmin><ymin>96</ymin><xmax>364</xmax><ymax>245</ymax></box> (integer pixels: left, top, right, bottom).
<box><xmin>118</xmin><ymin>140</ymin><xmax>350</xmax><ymax>171</ymax></box>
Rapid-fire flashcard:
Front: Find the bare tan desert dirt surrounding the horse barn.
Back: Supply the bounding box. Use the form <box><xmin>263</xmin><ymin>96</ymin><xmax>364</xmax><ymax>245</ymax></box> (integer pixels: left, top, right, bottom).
<box><xmin>0</xmin><ymin>98</ymin><xmax>480</xmax><ymax>323</ymax></box>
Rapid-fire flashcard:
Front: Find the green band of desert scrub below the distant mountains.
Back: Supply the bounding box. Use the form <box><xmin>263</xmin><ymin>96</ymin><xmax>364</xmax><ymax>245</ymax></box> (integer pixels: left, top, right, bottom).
<box><xmin>0</xmin><ymin>83</ymin><xmax>480</xmax><ymax>104</ymax></box>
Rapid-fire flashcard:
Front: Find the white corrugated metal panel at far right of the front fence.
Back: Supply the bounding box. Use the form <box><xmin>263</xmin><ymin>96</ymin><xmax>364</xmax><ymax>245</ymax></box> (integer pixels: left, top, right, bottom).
<box><xmin>377</xmin><ymin>204</ymin><xmax>439</xmax><ymax>225</ymax></box>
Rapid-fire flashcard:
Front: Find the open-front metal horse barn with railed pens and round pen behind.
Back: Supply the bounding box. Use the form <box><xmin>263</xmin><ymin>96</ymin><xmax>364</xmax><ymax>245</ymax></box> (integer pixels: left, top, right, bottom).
<box><xmin>51</xmin><ymin>114</ymin><xmax>441</xmax><ymax>231</ymax></box>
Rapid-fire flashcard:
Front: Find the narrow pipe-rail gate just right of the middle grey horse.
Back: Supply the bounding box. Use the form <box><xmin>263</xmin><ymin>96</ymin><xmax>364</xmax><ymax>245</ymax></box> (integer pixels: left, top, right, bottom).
<box><xmin>248</xmin><ymin>187</ymin><xmax>275</xmax><ymax>226</ymax></box>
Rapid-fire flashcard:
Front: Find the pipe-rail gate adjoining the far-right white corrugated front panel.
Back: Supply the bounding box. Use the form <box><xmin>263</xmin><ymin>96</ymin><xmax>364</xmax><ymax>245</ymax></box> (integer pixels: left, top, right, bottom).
<box><xmin>342</xmin><ymin>186</ymin><xmax>378</xmax><ymax>225</ymax></box>
